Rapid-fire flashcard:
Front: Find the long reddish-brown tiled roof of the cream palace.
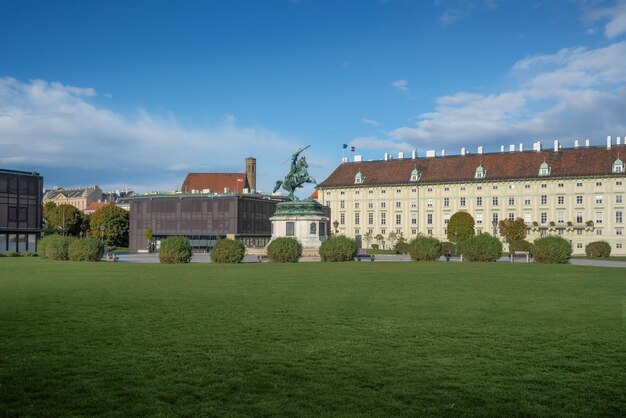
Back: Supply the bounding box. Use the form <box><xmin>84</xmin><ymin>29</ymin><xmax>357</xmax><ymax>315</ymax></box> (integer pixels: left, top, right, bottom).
<box><xmin>320</xmin><ymin>146</ymin><xmax>626</xmax><ymax>188</ymax></box>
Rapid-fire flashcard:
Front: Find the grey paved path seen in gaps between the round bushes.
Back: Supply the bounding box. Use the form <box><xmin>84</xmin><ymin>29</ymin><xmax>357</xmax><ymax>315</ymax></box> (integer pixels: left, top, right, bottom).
<box><xmin>103</xmin><ymin>253</ymin><xmax>626</xmax><ymax>268</ymax></box>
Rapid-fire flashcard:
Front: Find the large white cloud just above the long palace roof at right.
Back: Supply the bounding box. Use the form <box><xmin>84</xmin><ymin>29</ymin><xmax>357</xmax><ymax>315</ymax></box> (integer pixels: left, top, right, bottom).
<box><xmin>390</xmin><ymin>42</ymin><xmax>626</xmax><ymax>146</ymax></box>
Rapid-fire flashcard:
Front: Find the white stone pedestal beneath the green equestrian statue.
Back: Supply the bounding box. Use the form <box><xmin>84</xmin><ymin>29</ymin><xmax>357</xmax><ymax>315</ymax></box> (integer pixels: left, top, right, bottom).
<box><xmin>270</xmin><ymin>200</ymin><xmax>329</xmax><ymax>249</ymax></box>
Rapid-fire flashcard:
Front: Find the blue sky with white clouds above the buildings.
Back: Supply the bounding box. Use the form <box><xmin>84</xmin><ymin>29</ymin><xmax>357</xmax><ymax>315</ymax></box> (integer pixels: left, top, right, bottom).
<box><xmin>0</xmin><ymin>0</ymin><xmax>626</xmax><ymax>195</ymax></box>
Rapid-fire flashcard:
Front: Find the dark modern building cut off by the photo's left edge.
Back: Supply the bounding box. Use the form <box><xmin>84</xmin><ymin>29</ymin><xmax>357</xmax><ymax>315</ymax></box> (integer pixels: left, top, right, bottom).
<box><xmin>0</xmin><ymin>169</ymin><xmax>43</xmax><ymax>253</ymax></box>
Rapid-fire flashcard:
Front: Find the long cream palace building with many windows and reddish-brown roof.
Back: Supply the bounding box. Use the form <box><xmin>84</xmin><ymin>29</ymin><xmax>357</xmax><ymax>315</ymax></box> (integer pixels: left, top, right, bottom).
<box><xmin>318</xmin><ymin>137</ymin><xmax>626</xmax><ymax>255</ymax></box>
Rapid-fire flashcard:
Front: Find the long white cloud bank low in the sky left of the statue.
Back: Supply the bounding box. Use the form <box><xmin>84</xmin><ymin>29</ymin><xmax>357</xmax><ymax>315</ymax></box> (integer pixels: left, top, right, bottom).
<box><xmin>0</xmin><ymin>78</ymin><xmax>329</xmax><ymax>192</ymax></box>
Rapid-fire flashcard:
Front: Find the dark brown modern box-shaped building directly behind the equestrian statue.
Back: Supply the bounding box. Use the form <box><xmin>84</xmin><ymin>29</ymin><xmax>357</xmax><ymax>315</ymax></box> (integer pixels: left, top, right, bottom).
<box><xmin>122</xmin><ymin>193</ymin><xmax>286</xmax><ymax>251</ymax></box>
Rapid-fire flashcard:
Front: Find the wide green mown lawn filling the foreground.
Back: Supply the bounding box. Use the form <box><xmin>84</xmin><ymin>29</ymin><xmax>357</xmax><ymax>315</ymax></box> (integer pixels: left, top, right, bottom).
<box><xmin>0</xmin><ymin>258</ymin><xmax>626</xmax><ymax>416</ymax></box>
